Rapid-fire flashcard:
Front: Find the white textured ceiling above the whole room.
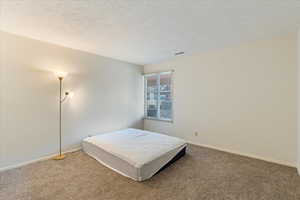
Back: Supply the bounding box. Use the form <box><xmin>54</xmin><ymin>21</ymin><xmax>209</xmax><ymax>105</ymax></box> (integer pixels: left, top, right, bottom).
<box><xmin>0</xmin><ymin>0</ymin><xmax>300</xmax><ymax>64</ymax></box>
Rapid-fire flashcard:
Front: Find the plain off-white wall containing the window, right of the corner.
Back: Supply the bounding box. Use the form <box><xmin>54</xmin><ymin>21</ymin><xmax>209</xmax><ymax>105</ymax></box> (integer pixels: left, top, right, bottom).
<box><xmin>144</xmin><ymin>34</ymin><xmax>297</xmax><ymax>166</ymax></box>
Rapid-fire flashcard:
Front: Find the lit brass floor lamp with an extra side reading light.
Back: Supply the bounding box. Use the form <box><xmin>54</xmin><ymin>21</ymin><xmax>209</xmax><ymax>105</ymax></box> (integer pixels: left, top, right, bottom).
<box><xmin>53</xmin><ymin>72</ymin><xmax>69</xmax><ymax>160</ymax></box>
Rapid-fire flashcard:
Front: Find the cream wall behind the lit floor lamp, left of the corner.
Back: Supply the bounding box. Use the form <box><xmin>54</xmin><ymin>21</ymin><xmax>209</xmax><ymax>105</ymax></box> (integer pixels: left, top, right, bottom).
<box><xmin>0</xmin><ymin>32</ymin><xmax>143</xmax><ymax>169</ymax></box>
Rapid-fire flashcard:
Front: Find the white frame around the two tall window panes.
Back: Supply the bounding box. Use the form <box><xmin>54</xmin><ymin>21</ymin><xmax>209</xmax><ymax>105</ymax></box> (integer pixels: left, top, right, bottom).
<box><xmin>143</xmin><ymin>70</ymin><xmax>174</xmax><ymax>123</ymax></box>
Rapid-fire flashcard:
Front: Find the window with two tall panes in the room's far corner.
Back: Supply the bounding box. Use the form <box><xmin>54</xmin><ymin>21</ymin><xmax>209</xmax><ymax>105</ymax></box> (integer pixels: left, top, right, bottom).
<box><xmin>144</xmin><ymin>72</ymin><xmax>173</xmax><ymax>121</ymax></box>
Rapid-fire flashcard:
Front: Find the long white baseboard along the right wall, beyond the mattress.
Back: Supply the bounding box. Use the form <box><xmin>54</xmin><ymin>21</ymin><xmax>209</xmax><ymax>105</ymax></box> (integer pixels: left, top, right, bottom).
<box><xmin>187</xmin><ymin>141</ymin><xmax>300</xmax><ymax>168</ymax></box>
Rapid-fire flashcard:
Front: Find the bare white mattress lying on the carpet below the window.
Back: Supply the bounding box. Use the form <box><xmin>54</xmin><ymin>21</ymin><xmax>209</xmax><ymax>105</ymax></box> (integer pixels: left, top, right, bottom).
<box><xmin>82</xmin><ymin>129</ymin><xmax>186</xmax><ymax>181</ymax></box>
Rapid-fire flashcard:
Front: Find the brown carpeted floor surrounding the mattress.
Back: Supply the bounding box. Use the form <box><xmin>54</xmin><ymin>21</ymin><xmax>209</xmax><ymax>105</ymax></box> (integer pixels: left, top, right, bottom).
<box><xmin>0</xmin><ymin>145</ymin><xmax>300</xmax><ymax>200</ymax></box>
